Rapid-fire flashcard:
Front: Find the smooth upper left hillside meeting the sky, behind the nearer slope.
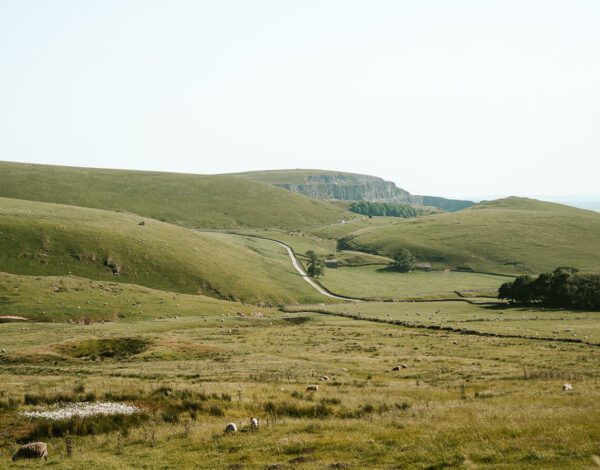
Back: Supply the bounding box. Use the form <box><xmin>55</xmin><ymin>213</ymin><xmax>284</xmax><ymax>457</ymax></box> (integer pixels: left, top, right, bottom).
<box><xmin>0</xmin><ymin>162</ymin><xmax>353</xmax><ymax>228</ymax></box>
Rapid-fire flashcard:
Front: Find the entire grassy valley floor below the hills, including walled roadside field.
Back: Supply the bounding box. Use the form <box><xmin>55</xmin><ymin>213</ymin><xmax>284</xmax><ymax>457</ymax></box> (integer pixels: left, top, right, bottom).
<box><xmin>0</xmin><ymin>239</ymin><xmax>600</xmax><ymax>470</ymax></box>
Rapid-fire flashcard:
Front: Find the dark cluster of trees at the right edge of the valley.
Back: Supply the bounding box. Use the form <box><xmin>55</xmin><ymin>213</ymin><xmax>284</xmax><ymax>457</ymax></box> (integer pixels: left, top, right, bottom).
<box><xmin>498</xmin><ymin>267</ymin><xmax>600</xmax><ymax>309</ymax></box>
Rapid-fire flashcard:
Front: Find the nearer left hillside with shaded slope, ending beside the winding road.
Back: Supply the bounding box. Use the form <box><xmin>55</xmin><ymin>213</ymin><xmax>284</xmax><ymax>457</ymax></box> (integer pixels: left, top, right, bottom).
<box><xmin>0</xmin><ymin>198</ymin><xmax>324</xmax><ymax>304</ymax></box>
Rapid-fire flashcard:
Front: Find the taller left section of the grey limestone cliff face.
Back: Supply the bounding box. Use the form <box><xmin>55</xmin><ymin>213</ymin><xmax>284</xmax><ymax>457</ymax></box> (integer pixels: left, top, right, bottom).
<box><xmin>278</xmin><ymin>174</ymin><xmax>411</xmax><ymax>202</ymax></box>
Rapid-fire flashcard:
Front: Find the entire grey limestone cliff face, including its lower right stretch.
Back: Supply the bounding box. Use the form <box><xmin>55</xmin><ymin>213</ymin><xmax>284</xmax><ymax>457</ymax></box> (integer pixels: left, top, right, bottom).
<box><xmin>277</xmin><ymin>173</ymin><xmax>474</xmax><ymax>212</ymax></box>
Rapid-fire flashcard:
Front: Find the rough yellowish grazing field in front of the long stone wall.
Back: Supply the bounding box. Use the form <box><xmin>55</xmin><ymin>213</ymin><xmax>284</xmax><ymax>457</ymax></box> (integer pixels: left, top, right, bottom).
<box><xmin>0</xmin><ymin>300</ymin><xmax>600</xmax><ymax>469</ymax></box>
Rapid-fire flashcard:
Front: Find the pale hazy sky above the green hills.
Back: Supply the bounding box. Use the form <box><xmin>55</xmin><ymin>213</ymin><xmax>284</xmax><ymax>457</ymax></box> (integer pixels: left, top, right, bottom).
<box><xmin>0</xmin><ymin>0</ymin><xmax>600</xmax><ymax>197</ymax></box>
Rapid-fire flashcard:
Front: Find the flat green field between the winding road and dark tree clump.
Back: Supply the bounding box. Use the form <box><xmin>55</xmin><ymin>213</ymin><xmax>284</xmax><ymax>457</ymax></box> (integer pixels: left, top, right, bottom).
<box><xmin>319</xmin><ymin>266</ymin><xmax>507</xmax><ymax>300</ymax></box>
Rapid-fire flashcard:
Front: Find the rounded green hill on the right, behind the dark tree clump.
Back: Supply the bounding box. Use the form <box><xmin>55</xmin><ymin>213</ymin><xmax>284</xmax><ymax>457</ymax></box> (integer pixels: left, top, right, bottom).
<box><xmin>346</xmin><ymin>197</ymin><xmax>600</xmax><ymax>273</ymax></box>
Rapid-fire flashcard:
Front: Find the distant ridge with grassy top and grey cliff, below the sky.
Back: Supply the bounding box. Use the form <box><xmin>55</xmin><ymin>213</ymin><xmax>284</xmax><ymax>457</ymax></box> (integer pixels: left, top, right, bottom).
<box><xmin>233</xmin><ymin>169</ymin><xmax>475</xmax><ymax>212</ymax></box>
